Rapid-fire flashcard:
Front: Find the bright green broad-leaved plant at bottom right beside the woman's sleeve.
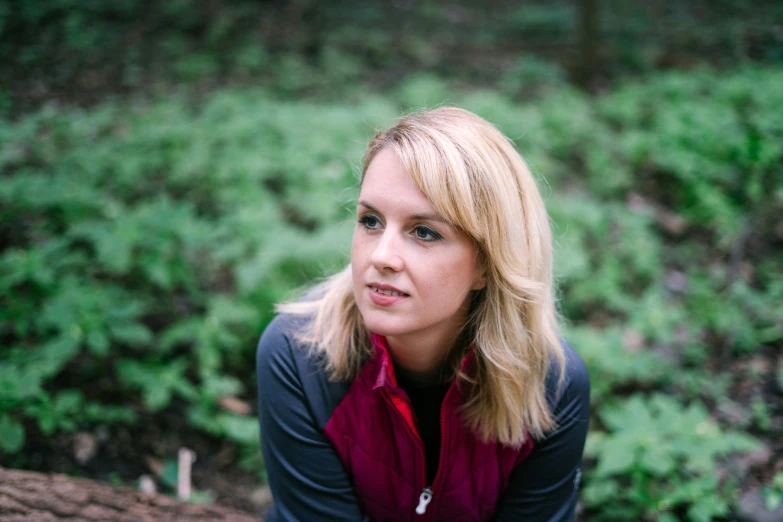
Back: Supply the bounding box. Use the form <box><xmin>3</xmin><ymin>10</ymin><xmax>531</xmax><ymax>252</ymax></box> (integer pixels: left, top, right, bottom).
<box><xmin>583</xmin><ymin>394</ymin><xmax>757</xmax><ymax>522</ymax></box>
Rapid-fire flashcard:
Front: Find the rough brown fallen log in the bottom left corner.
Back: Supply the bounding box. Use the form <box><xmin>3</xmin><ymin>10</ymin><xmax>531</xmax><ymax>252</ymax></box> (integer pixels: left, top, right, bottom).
<box><xmin>0</xmin><ymin>467</ymin><xmax>261</xmax><ymax>522</ymax></box>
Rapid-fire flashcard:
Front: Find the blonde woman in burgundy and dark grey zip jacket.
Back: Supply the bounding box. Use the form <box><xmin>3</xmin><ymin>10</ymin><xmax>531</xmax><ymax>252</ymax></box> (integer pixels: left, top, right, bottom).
<box><xmin>257</xmin><ymin>107</ymin><xmax>590</xmax><ymax>522</ymax></box>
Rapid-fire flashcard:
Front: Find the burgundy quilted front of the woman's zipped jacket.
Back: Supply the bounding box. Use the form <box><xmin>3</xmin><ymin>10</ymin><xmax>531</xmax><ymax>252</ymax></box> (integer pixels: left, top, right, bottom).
<box><xmin>325</xmin><ymin>335</ymin><xmax>533</xmax><ymax>522</ymax></box>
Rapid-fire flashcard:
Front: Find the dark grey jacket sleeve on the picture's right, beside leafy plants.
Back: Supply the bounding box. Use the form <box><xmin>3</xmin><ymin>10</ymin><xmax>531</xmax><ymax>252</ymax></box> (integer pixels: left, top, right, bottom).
<box><xmin>494</xmin><ymin>343</ymin><xmax>590</xmax><ymax>522</ymax></box>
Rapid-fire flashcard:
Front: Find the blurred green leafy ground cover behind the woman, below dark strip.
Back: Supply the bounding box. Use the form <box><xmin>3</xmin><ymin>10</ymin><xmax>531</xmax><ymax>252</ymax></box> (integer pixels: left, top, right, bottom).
<box><xmin>0</xmin><ymin>67</ymin><xmax>783</xmax><ymax>522</ymax></box>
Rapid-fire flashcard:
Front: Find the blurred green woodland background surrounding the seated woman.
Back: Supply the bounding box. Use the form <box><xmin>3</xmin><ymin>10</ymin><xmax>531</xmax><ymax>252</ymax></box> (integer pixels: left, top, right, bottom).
<box><xmin>0</xmin><ymin>0</ymin><xmax>783</xmax><ymax>522</ymax></box>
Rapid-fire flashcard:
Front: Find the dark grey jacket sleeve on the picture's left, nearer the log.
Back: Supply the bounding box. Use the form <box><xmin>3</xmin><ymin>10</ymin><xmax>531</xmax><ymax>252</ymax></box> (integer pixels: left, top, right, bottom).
<box><xmin>256</xmin><ymin>312</ymin><xmax>366</xmax><ymax>522</ymax></box>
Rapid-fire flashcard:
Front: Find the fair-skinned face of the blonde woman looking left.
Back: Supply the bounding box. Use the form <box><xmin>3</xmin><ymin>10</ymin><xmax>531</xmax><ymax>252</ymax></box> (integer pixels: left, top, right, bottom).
<box><xmin>351</xmin><ymin>148</ymin><xmax>485</xmax><ymax>341</ymax></box>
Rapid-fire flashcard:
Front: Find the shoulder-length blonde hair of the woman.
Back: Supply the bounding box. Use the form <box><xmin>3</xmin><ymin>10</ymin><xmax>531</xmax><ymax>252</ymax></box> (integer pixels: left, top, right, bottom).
<box><xmin>277</xmin><ymin>107</ymin><xmax>565</xmax><ymax>446</ymax></box>
